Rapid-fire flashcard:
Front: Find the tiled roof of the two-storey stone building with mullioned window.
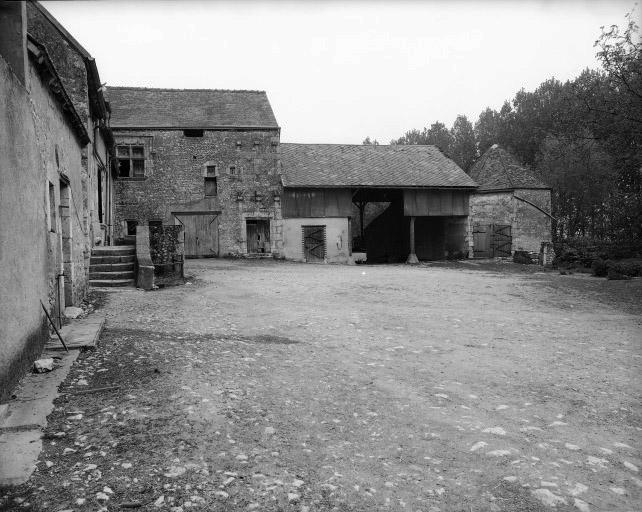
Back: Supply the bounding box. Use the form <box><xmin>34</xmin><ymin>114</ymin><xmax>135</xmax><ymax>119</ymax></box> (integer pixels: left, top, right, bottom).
<box><xmin>107</xmin><ymin>87</ymin><xmax>278</xmax><ymax>128</ymax></box>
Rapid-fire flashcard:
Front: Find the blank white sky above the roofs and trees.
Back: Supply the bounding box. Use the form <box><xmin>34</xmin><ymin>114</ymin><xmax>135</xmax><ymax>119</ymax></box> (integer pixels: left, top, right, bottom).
<box><xmin>42</xmin><ymin>0</ymin><xmax>639</xmax><ymax>144</ymax></box>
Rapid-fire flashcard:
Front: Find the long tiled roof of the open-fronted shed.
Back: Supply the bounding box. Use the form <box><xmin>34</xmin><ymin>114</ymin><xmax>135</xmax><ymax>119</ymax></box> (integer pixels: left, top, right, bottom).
<box><xmin>281</xmin><ymin>144</ymin><xmax>477</xmax><ymax>188</ymax></box>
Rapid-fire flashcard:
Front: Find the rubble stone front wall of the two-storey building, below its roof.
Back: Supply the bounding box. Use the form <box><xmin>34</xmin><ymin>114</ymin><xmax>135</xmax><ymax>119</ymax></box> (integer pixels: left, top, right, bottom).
<box><xmin>114</xmin><ymin>130</ymin><xmax>283</xmax><ymax>256</ymax></box>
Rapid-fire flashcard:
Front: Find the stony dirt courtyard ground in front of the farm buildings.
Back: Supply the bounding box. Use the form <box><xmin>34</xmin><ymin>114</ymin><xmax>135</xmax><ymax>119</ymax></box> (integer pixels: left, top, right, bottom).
<box><xmin>0</xmin><ymin>260</ymin><xmax>642</xmax><ymax>512</ymax></box>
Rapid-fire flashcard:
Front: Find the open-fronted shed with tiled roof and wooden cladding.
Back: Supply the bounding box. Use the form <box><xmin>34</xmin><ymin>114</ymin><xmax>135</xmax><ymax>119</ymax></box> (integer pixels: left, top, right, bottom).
<box><xmin>281</xmin><ymin>144</ymin><xmax>476</xmax><ymax>263</ymax></box>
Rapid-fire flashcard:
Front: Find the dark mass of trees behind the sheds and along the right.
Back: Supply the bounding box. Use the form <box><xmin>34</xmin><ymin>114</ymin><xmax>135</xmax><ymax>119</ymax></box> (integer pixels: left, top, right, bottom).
<box><xmin>364</xmin><ymin>13</ymin><xmax>642</xmax><ymax>241</ymax></box>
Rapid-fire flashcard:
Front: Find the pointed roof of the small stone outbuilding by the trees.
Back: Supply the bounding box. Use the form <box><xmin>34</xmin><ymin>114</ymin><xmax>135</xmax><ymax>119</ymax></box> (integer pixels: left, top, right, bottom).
<box><xmin>469</xmin><ymin>144</ymin><xmax>550</xmax><ymax>192</ymax></box>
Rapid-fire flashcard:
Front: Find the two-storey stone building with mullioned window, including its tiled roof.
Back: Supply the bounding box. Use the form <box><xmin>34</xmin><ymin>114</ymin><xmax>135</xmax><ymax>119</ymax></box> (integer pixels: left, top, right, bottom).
<box><xmin>109</xmin><ymin>87</ymin><xmax>282</xmax><ymax>257</ymax></box>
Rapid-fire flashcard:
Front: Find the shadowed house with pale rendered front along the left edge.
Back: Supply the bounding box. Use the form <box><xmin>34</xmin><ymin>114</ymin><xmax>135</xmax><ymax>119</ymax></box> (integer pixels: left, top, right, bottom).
<box><xmin>0</xmin><ymin>2</ymin><xmax>109</xmax><ymax>402</ymax></box>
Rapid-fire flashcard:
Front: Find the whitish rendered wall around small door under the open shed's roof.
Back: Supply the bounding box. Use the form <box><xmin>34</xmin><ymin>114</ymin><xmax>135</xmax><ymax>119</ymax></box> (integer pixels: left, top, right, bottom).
<box><xmin>283</xmin><ymin>217</ymin><xmax>351</xmax><ymax>263</ymax></box>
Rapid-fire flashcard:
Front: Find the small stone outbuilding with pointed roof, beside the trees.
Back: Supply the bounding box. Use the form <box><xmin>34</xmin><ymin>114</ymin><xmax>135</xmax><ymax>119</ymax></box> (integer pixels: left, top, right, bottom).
<box><xmin>469</xmin><ymin>144</ymin><xmax>552</xmax><ymax>257</ymax></box>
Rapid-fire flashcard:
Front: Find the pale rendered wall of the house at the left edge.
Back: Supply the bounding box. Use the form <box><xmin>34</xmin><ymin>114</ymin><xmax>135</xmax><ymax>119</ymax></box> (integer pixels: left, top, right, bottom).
<box><xmin>0</xmin><ymin>57</ymin><xmax>86</xmax><ymax>400</ymax></box>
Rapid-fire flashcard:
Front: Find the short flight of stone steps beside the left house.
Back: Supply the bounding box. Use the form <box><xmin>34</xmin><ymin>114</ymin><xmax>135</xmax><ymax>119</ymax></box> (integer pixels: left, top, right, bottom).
<box><xmin>89</xmin><ymin>245</ymin><xmax>136</xmax><ymax>286</ymax></box>
